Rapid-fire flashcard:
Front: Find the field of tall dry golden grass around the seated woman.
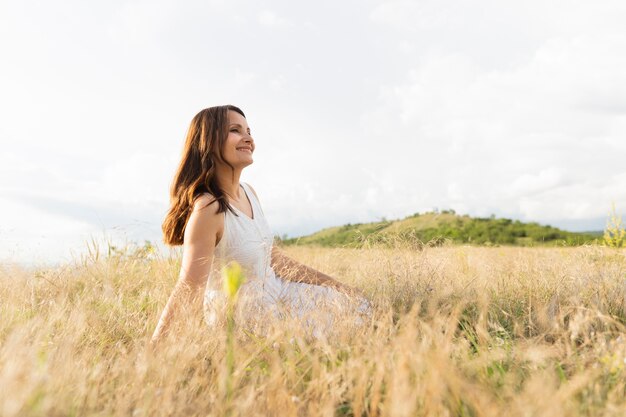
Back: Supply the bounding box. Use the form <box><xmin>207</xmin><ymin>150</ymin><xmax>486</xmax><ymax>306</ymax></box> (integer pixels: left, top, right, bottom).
<box><xmin>0</xmin><ymin>242</ymin><xmax>626</xmax><ymax>417</ymax></box>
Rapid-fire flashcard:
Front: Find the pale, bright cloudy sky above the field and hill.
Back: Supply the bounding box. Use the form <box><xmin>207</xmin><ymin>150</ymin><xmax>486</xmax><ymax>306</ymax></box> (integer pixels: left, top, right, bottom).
<box><xmin>0</xmin><ymin>0</ymin><xmax>626</xmax><ymax>264</ymax></box>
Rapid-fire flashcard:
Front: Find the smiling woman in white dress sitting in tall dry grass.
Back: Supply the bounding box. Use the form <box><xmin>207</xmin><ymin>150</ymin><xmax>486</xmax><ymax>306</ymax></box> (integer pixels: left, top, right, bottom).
<box><xmin>152</xmin><ymin>105</ymin><xmax>370</xmax><ymax>344</ymax></box>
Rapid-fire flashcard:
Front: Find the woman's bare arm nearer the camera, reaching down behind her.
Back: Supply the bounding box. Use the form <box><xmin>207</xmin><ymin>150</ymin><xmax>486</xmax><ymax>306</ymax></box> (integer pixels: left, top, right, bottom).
<box><xmin>151</xmin><ymin>195</ymin><xmax>224</xmax><ymax>346</ymax></box>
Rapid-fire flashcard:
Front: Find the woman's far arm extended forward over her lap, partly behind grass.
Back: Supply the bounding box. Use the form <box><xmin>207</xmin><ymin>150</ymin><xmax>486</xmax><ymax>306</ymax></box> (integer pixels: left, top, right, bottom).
<box><xmin>272</xmin><ymin>246</ymin><xmax>361</xmax><ymax>295</ymax></box>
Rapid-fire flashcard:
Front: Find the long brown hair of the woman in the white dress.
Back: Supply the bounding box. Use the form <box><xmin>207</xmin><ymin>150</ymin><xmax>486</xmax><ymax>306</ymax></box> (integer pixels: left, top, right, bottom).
<box><xmin>161</xmin><ymin>105</ymin><xmax>246</xmax><ymax>246</ymax></box>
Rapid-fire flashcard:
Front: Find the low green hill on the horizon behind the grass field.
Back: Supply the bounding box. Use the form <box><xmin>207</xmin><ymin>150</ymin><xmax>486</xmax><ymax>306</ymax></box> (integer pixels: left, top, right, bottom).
<box><xmin>282</xmin><ymin>210</ymin><xmax>601</xmax><ymax>247</ymax></box>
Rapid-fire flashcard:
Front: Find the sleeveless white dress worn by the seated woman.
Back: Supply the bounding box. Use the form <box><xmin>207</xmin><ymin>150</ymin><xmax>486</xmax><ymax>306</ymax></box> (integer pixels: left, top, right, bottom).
<box><xmin>204</xmin><ymin>183</ymin><xmax>371</xmax><ymax>337</ymax></box>
